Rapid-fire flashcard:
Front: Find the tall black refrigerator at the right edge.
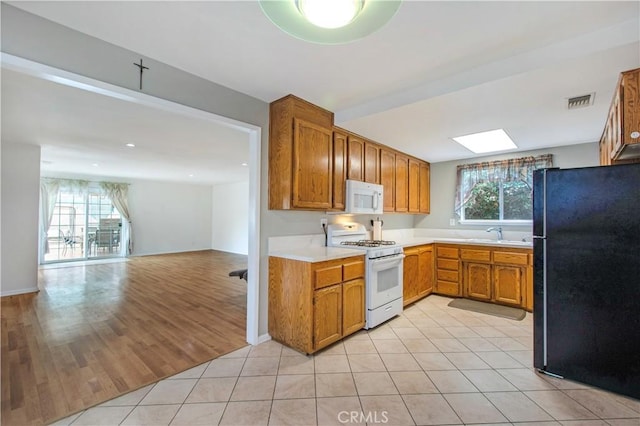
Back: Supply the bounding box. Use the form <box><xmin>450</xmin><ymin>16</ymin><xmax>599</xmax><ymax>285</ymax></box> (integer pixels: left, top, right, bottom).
<box><xmin>533</xmin><ymin>164</ymin><xmax>640</xmax><ymax>399</ymax></box>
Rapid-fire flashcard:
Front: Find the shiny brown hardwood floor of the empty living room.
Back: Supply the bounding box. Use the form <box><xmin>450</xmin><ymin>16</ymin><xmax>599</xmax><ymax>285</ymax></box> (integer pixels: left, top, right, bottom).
<box><xmin>1</xmin><ymin>250</ymin><xmax>247</xmax><ymax>425</ymax></box>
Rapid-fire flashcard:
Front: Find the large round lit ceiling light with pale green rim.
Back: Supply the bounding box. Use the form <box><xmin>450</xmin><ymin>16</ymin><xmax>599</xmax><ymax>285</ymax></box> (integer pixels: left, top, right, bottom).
<box><xmin>259</xmin><ymin>0</ymin><xmax>401</xmax><ymax>44</ymax></box>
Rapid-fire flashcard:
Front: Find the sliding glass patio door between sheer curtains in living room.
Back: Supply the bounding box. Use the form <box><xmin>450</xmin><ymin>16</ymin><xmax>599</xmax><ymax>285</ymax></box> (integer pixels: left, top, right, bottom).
<box><xmin>44</xmin><ymin>190</ymin><xmax>122</xmax><ymax>263</ymax></box>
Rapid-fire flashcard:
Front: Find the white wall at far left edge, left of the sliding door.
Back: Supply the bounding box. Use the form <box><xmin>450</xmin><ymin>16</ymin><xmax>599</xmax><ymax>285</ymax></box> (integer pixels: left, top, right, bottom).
<box><xmin>0</xmin><ymin>141</ymin><xmax>40</xmax><ymax>296</ymax></box>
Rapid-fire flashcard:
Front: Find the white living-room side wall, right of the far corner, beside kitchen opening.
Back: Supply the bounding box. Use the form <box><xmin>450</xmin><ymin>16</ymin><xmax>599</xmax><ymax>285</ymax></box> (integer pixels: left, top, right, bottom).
<box><xmin>211</xmin><ymin>182</ymin><xmax>249</xmax><ymax>254</ymax></box>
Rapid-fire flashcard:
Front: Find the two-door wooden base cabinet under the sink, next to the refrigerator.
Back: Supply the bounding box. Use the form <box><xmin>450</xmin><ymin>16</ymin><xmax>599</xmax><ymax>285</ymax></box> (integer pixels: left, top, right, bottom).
<box><xmin>460</xmin><ymin>246</ymin><xmax>533</xmax><ymax>310</ymax></box>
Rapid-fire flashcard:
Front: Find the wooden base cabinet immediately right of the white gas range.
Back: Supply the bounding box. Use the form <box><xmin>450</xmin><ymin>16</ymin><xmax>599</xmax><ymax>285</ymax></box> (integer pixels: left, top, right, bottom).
<box><xmin>403</xmin><ymin>244</ymin><xmax>433</xmax><ymax>306</ymax></box>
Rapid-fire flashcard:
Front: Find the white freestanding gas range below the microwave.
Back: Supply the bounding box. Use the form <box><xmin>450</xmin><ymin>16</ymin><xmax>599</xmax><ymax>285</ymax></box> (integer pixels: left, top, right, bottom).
<box><xmin>327</xmin><ymin>223</ymin><xmax>404</xmax><ymax>329</ymax></box>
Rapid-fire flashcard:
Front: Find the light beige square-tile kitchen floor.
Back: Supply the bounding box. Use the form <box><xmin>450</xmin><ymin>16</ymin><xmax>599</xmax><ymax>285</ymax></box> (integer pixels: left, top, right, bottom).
<box><xmin>55</xmin><ymin>296</ymin><xmax>640</xmax><ymax>426</ymax></box>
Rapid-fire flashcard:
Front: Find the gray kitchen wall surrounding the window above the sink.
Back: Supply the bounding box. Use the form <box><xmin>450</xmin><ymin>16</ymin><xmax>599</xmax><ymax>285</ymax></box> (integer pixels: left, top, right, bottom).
<box><xmin>414</xmin><ymin>142</ymin><xmax>600</xmax><ymax>231</ymax></box>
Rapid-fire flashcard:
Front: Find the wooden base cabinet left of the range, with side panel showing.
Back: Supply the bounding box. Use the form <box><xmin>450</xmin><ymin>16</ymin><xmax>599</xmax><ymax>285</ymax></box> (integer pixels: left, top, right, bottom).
<box><xmin>269</xmin><ymin>256</ymin><xmax>365</xmax><ymax>354</ymax></box>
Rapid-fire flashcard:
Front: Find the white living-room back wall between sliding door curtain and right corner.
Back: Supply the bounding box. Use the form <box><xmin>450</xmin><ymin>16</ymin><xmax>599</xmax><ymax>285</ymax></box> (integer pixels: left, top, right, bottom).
<box><xmin>129</xmin><ymin>180</ymin><xmax>214</xmax><ymax>256</ymax></box>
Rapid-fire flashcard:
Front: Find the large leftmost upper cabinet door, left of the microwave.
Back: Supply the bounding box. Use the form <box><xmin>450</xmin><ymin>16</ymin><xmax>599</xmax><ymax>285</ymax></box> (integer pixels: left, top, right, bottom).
<box><xmin>291</xmin><ymin>119</ymin><xmax>333</xmax><ymax>209</ymax></box>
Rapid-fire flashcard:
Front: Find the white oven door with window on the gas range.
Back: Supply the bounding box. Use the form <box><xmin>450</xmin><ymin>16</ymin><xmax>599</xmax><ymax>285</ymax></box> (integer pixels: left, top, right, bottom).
<box><xmin>366</xmin><ymin>254</ymin><xmax>404</xmax><ymax>309</ymax></box>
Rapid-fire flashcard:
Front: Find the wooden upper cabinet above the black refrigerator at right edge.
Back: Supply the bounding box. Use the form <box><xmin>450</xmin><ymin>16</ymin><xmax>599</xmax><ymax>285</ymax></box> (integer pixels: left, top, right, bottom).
<box><xmin>600</xmin><ymin>68</ymin><xmax>640</xmax><ymax>166</ymax></box>
